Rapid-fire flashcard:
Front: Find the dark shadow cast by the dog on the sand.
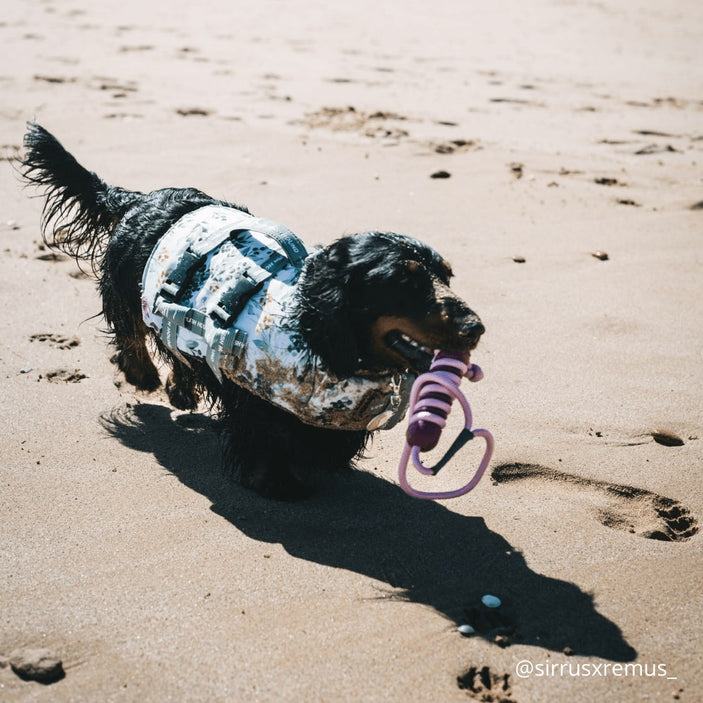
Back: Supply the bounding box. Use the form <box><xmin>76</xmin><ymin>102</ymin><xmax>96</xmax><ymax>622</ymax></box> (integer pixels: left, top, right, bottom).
<box><xmin>102</xmin><ymin>404</ymin><xmax>636</xmax><ymax>661</ymax></box>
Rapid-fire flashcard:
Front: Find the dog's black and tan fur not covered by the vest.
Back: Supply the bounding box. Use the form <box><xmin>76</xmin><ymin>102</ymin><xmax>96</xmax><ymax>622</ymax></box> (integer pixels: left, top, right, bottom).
<box><xmin>19</xmin><ymin>123</ymin><xmax>484</xmax><ymax>500</ymax></box>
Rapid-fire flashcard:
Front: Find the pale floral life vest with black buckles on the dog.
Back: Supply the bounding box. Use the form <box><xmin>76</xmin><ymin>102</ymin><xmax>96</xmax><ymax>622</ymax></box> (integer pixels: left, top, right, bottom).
<box><xmin>142</xmin><ymin>205</ymin><xmax>414</xmax><ymax>431</ymax></box>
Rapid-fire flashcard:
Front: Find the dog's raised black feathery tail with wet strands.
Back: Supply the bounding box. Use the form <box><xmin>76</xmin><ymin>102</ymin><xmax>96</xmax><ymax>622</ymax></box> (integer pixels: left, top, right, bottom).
<box><xmin>19</xmin><ymin>122</ymin><xmax>143</xmax><ymax>271</ymax></box>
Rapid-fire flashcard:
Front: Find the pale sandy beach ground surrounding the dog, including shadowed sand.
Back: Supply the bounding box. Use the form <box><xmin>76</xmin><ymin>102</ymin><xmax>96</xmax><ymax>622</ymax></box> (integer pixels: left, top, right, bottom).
<box><xmin>0</xmin><ymin>0</ymin><xmax>703</xmax><ymax>703</ymax></box>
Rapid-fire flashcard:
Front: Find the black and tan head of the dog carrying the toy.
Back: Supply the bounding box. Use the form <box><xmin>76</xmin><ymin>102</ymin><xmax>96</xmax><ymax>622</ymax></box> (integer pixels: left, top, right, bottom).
<box><xmin>299</xmin><ymin>232</ymin><xmax>484</xmax><ymax>376</ymax></box>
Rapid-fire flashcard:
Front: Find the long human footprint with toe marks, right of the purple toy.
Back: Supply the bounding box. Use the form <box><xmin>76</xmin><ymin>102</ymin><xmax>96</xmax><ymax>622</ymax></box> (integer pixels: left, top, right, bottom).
<box><xmin>491</xmin><ymin>463</ymin><xmax>698</xmax><ymax>542</ymax></box>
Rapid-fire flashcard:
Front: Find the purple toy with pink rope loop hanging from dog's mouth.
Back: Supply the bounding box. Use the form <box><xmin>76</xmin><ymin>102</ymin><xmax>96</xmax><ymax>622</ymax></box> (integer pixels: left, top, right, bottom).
<box><xmin>398</xmin><ymin>351</ymin><xmax>493</xmax><ymax>500</ymax></box>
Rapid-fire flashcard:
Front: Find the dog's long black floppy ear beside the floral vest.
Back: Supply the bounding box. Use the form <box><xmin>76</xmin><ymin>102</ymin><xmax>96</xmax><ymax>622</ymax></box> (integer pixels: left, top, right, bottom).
<box><xmin>298</xmin><ymin>247</ymin><xmax>359</xmax><ymax>377</ymax></box>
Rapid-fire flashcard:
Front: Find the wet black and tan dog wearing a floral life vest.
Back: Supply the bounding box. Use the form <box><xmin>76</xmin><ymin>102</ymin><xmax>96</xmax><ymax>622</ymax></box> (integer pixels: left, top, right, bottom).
<box><xmin>18</xmin><ymin>123</ymin><xmax>485</xmax><ymax>501</ymax></box>
